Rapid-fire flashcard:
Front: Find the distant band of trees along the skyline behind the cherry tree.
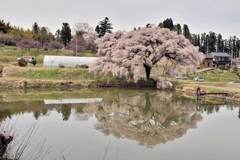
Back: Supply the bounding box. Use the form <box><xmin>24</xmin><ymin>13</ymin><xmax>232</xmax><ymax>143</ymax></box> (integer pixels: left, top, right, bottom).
<box><xmin>0</xmin><ymin>18</ymin><xmax>240</xmax><ymax>58</ymax></box>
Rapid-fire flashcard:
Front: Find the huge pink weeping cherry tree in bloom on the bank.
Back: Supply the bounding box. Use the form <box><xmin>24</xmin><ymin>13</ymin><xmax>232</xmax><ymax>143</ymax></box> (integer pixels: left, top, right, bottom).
<box><xmin>89</xmin><ymin>25</ymin><xmax>204</xmax><ymax>82</ymax></box>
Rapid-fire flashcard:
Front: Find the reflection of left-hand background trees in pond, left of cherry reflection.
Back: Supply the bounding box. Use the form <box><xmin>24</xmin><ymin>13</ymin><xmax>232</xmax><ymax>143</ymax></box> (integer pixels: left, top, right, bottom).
<box><xmin>0</xmin><ymin>101</ymin><xmax>93</xmax><ymax>122</ymax></box>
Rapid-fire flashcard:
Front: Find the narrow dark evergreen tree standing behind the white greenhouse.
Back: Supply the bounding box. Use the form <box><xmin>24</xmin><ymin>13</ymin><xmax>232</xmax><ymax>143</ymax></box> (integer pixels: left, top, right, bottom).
<box><xmin>60</xmin><ymin>22</ymin><xmax>72</xmax><ymax>47</ymax></box>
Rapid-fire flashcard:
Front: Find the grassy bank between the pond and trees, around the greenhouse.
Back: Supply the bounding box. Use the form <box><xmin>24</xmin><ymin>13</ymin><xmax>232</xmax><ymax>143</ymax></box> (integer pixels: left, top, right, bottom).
<box><xmin>0</xmin><ymin>46</ymin><xmax>240</xmax><ymax>102</ymax></box>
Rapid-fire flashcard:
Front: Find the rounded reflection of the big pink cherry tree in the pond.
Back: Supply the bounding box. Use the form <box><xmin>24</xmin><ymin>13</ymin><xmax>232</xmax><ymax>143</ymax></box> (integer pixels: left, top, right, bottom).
<box><xmin>86</xmin><ymin>91</ymin><xmax>202</xmax><ymax>147</ymax></box>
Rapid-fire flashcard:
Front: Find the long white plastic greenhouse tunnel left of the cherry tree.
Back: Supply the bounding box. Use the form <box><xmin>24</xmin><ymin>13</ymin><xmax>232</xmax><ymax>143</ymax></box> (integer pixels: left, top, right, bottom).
<box><xmin>43</xmin><ymin>56</ymin><xmax>97</xmax><ymax>68</ymax></box>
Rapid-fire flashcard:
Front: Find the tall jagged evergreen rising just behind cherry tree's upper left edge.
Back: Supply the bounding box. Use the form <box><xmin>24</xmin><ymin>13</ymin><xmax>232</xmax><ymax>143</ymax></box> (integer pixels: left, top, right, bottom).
<box><xmin>95</xmin><ymin>17</ymin><xmax>113</xmax><ymax>37</ymax></box>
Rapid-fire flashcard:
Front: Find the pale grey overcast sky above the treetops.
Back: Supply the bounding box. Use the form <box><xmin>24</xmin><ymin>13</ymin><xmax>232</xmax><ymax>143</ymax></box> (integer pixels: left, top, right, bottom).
<box><xmin>0</xmin><ymin>0</ymin><xmax>240</xmax><ymax>38</ymax></box>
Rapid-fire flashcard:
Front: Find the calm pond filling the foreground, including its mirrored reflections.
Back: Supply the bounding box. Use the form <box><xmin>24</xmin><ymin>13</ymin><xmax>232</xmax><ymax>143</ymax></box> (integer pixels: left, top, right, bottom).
<box><xmin>0</xmin><ymin>88</ymin><xmax>240</xmax><ymax>160</ymax></box>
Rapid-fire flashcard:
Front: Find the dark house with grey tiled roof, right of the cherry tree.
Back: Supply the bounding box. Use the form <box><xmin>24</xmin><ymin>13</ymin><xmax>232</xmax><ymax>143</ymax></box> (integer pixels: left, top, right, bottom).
<box><xmin>211</xmin><ymin>52</ymin><xmax>231</xmax><ymax>67</ymax></box>
